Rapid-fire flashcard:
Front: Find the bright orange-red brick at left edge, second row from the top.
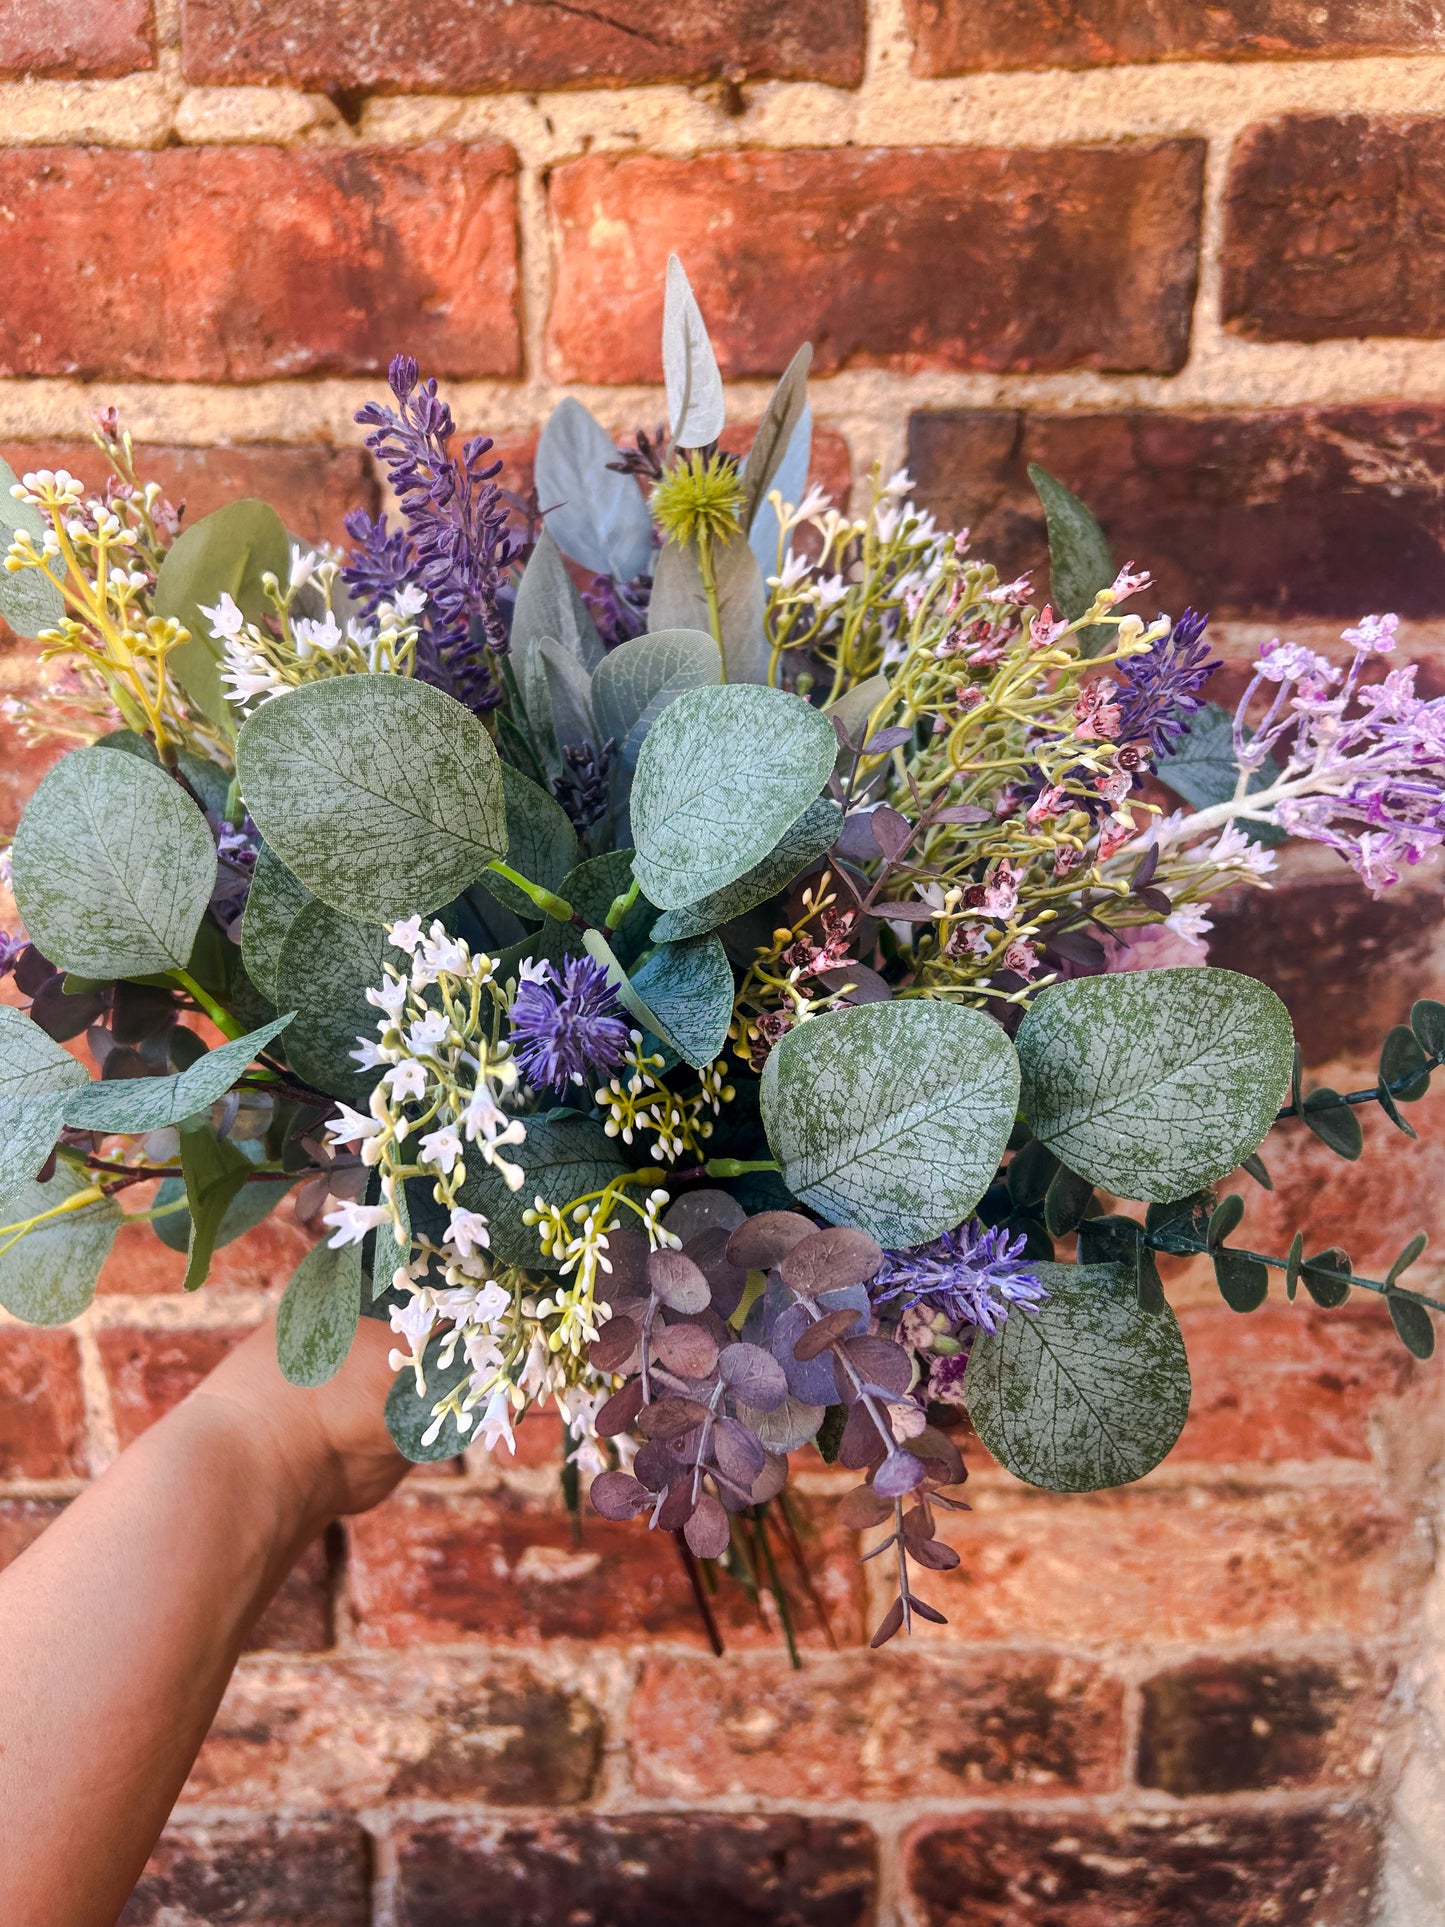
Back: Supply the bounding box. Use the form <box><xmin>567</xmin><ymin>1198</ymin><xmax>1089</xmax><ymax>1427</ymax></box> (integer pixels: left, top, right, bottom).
<box><xmin>0</xmin><ymin>145</ymin><xmax>522</xmax><ymax>382</ymax></box>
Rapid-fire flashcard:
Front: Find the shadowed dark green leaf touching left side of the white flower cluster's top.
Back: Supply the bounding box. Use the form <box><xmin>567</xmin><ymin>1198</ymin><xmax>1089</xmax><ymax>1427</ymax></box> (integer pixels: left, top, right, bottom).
<box><xmin>276</xmin><ymin>904</ymin><xmax>397</xmax><ymax>1104</ymax></box>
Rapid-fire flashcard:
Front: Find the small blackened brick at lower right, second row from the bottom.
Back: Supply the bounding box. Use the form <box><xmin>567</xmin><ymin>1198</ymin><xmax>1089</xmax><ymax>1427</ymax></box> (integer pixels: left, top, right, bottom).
<box><xmin>1139</xmin><ymin>1657</ymin><xmax>1391</xmax><ymax>1800</ymax></box>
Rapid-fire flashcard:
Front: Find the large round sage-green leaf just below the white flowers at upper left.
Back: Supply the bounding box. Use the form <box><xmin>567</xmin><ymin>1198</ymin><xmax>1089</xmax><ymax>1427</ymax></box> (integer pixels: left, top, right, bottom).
<box><xmin>235</xmin><ymin>676</ymin><xmax>507</xmax><ymax>923</ymax></box>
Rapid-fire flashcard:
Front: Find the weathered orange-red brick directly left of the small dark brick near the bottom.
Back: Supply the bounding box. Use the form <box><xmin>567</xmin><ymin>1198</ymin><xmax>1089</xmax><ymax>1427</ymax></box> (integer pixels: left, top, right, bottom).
<box><xmin>630</xmin><ymin>1651</ymin><xmax>1123</xmax><ymax>1800</ymax></box>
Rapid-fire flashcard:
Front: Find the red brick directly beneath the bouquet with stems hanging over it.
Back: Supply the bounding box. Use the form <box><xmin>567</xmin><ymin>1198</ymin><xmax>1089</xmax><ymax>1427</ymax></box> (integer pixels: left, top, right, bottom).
<box><xmin>349</xmin><ymin>1490</ymin><xmax>861</xmax><ymax>1648</ymax></box>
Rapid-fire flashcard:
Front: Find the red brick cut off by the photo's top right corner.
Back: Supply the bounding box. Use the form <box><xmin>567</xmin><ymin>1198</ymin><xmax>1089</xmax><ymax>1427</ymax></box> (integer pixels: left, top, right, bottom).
<box><xmin>907</xmin><ymin>0</ymin><xmax>1445</xmax><ymax>73</ymax></box>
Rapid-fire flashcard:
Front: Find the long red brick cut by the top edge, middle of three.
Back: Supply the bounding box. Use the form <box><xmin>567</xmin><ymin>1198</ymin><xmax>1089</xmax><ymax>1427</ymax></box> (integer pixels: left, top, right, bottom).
<box><xmin>181</xmin><ymin>0</ymin><xmax>867</xmax><ymax>94</ymax></box>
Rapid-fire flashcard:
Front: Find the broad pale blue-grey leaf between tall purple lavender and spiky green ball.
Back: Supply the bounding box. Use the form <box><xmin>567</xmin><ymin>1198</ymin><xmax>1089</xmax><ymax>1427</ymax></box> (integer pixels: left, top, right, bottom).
<box><xmin>536</xmin><ymin>395</ymin><xmax>653</xmax><ymax>578</ymax></box>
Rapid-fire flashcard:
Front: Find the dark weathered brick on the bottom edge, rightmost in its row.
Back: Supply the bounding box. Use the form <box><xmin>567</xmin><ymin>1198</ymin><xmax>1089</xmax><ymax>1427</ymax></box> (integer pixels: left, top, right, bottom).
<box><xmin>907</xmin><ymin>1809</ymin><xmax>1376</xmax><ymax>1927</ymax></box>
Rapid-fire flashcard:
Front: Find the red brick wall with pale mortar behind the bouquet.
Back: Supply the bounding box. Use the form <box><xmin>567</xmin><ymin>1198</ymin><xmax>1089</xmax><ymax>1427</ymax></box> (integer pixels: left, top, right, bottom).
<box><xmin>0</xmin><ymin>0</ymin><xmax>1445</xmax><ymax>1927</ymax></box>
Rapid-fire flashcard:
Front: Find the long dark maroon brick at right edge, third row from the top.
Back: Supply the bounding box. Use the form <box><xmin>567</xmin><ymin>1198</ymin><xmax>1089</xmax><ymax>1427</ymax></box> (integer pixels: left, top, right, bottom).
<box><xmin>907</xmin><ymin>403</ymin><xmax>1445</xmax><ymax>619</ymax></box>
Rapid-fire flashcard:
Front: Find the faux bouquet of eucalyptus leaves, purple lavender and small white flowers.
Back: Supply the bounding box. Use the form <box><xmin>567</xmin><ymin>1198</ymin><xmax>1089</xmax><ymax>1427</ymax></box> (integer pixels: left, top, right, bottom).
<box><xmin>0</xmin><ymin>262</ymin><xmax>1445</xmax><ymax>1644</ymax></box>
